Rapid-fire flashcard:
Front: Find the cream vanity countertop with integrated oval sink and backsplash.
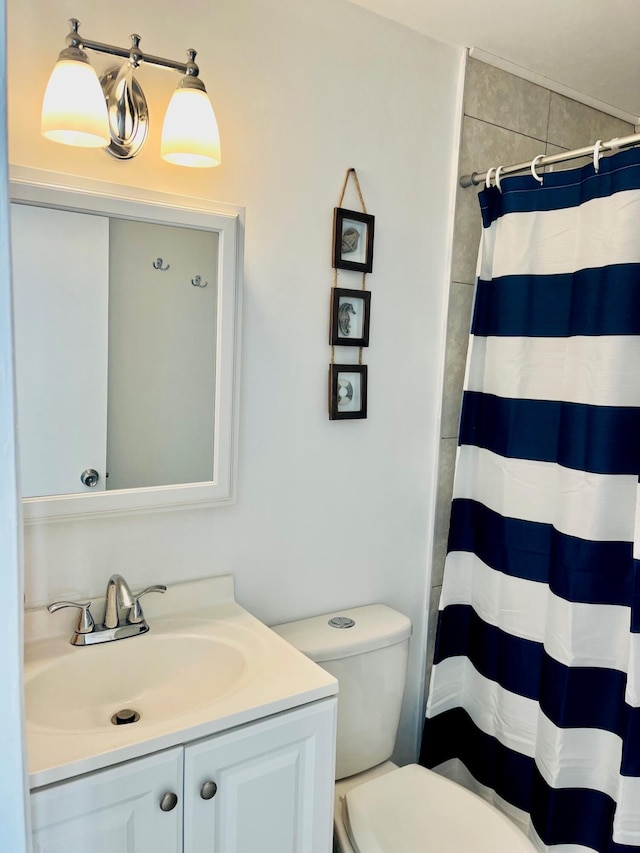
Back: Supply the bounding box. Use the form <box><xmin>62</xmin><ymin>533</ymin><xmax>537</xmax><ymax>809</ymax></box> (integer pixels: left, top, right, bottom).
<box><xmin>23</xmin><ymin>575</ymin><xmax>337</xmax><ymax>788</ymax></box>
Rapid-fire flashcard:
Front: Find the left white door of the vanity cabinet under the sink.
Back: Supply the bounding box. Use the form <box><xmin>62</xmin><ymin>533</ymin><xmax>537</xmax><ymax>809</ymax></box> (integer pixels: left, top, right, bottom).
<box><xmin>31</xmin><ymin>748</ymin><xmax>183</xmax><ymax>853</ymax></box>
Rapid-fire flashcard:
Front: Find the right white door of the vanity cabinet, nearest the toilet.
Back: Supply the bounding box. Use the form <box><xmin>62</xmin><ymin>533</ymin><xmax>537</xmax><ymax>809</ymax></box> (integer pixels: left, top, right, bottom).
<box><xmin>184</xmin><ymin>699</ymin><xmax>337</xmax><ymax>853</ymax></box>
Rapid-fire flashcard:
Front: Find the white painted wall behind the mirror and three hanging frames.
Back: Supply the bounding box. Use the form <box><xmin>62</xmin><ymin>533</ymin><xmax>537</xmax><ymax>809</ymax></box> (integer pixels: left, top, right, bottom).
<box><xmin>8</xmin><ymin>0</ymin><xmax>461</xmax><ymax>758</ymax></box>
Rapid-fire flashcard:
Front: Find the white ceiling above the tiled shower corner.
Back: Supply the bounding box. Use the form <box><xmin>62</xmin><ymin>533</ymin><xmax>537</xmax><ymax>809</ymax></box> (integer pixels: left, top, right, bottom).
<box><xmin>351</xmin><ymin>0</ymin><xmax>640</xmax><ymax>119</ymax></box>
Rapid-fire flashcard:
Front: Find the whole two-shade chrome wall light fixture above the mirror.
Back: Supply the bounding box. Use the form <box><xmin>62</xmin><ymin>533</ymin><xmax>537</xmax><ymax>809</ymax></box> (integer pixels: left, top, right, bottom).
<box><xmin>42</xmin><ymin>18</ymin><xmax>221</xmax><ymax>167</ymax></box>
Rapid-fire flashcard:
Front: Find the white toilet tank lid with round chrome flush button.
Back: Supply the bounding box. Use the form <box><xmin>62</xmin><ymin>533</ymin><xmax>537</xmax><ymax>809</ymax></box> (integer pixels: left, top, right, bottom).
<box><xmin>272</xmin><ymin>604</ymin><xmax>411</xmax><ymax>663</ymax></box>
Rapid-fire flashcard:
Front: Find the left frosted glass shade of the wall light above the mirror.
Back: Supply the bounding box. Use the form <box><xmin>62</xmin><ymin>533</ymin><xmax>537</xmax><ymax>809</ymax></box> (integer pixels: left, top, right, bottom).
<box><xmin>41</xmin><ymin>59</ymin><xmax>111</xmax><ymax>148</ymax></box>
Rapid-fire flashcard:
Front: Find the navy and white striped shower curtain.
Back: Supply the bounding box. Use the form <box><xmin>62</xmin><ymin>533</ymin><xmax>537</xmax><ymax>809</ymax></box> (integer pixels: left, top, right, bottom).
<box><xmin>420</xmin><ymin>149</ymin><xmax>640</xmax><ymax>853</ymax></box>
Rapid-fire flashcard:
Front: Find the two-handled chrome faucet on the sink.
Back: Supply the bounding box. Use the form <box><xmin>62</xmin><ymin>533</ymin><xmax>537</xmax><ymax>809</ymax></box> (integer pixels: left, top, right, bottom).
<box><xmin>48</xmin><ymin>574</ymin><xmax>167</xmax><ymax>646</ymax></box>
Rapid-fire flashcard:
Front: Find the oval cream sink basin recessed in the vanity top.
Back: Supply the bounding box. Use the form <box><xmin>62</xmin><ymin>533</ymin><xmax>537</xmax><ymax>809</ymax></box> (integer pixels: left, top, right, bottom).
<box><xmin>25</xmin><ymin>631</ymin><xmax>247</xmax><ymax>733</ymax></box>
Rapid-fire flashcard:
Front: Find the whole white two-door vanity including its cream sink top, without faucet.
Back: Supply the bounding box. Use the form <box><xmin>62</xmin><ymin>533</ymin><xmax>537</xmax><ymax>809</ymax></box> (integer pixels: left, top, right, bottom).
<box><xmin>25</xmin><ymin>576</ymin><xmax>338</xmax><ymax>853</ymax></box>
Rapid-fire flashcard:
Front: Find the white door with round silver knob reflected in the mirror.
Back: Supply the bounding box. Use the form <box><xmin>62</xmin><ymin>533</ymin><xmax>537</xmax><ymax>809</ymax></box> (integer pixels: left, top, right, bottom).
<box><xmin>11</xmin><ymin>203</ymin><xmax>109</xmax><ymax>497</ymax></box>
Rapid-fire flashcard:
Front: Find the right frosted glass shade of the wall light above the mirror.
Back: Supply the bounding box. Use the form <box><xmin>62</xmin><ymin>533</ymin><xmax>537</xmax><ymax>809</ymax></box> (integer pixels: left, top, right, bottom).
<box><xmin>160</xmin><ymin>83</ymin><xmax>221</xmax><ymax>168</ymax></box>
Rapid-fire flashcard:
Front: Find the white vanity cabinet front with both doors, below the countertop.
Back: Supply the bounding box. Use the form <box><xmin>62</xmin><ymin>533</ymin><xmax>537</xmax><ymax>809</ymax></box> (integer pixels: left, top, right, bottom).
<box><xmin>31</xmin><ymin>698</ymin><xmax>336</xmax><ymax>853</ymax></box>
